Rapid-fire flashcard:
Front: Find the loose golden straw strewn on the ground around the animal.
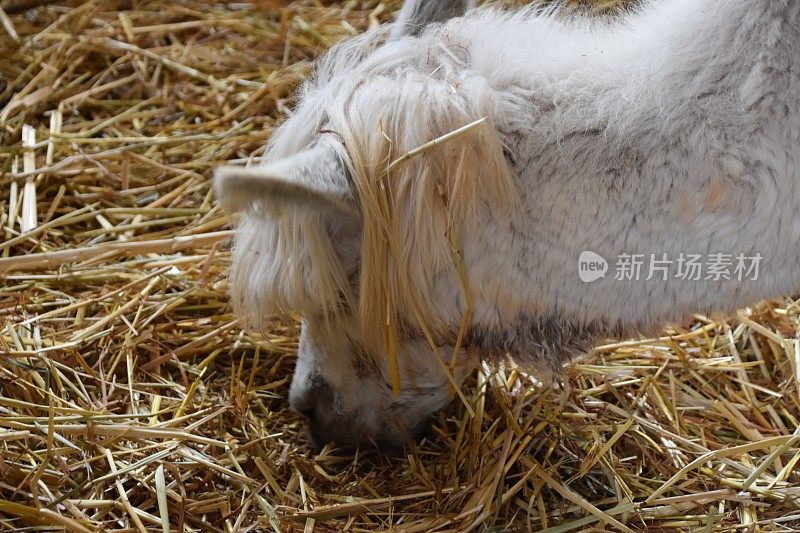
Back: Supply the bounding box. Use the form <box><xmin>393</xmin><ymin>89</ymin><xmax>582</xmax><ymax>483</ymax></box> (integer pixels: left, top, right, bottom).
<box><xmin>0</xmin><ymin>0</ymin><xmax>800</xmax><ymax>532</ymax></box>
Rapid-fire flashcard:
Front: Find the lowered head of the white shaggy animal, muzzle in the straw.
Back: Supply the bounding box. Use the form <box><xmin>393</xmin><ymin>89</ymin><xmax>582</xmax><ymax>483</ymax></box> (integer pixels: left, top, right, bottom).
<box><xmin>215</xmin><ymin>1</ymin><xmax>510</xmax><ymax>447</ymax></box>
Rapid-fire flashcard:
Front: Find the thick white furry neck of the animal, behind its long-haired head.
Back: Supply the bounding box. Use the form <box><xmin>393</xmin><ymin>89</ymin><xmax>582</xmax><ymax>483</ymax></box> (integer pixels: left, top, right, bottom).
<box><xmin>456</xmin><ymin>0</ymin><xmax>800</xmax><ymax>366</ymax></box>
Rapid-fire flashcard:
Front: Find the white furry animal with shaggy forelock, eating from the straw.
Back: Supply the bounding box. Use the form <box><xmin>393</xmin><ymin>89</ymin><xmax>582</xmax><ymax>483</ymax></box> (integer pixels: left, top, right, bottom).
<box><xmin>215</xmin><ymin>0</ymin><xmax>800</xmax><ymax>446</ymax></box>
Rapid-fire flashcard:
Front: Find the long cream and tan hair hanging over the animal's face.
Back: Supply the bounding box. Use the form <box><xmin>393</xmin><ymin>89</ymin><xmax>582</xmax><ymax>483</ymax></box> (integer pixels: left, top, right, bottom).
<box><xmin>231</xmin><ymin>26</ymin><xmax>516</xmax><ymax>348</ymax></box>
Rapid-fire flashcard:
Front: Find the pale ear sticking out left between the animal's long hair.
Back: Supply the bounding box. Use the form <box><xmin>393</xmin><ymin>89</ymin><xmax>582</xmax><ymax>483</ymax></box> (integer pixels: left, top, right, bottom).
<box><xmin>214</xmin><ymin>136</ymin><xmax>358</xmax><ymax>220</ymax></box>
